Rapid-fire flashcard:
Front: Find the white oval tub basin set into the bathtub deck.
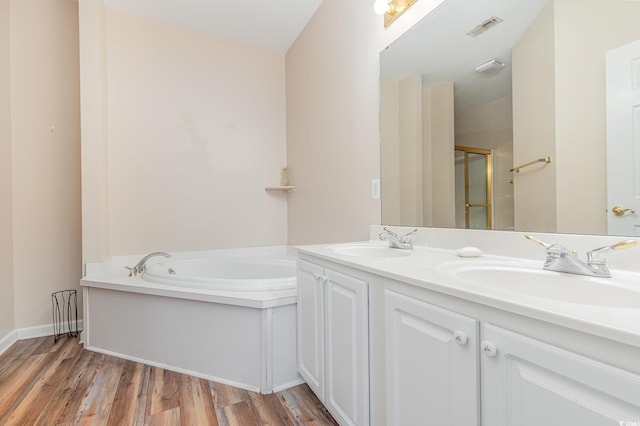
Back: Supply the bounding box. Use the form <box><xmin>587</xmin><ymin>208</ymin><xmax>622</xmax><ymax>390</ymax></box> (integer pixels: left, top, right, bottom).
<box><xmin>142</xmin><ymin>257</ymin><xmax>296</xmax><ymax>291</ymax></box>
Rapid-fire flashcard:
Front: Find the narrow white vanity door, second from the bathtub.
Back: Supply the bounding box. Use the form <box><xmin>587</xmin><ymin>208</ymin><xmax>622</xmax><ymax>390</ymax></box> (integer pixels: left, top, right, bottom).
<box><xmin>325</xmin><ymin>270</ymin><xmax>369</xmax><ymax>425</ymax></box>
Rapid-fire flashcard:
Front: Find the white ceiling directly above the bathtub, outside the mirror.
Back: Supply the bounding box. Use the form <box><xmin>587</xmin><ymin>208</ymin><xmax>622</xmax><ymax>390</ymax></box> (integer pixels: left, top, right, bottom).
<box><xmin>104</xmin><ymin>0</ymin><xmax>322</xmax><ymax>53</ymax></box>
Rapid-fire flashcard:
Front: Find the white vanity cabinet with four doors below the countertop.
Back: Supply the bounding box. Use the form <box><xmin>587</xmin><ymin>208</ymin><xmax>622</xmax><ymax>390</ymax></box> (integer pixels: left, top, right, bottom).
<box><xmin>297</xmin><ymin>253</ymin><xmax>640</xmax><ymax>426</ymax></box>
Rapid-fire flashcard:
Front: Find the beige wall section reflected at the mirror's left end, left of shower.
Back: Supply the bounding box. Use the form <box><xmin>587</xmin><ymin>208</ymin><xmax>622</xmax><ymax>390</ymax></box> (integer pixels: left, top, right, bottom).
<box><xmin>380</xmin><ymin>74</ymin><xmax>455</xmax><ymax>227</ymax></box>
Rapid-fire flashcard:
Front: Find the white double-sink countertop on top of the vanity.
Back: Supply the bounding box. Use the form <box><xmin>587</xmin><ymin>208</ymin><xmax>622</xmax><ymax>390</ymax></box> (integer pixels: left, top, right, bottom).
<box><xmin>295</xmin><ymin>241</ymin><xmax>640</xmax><ymax>347</ymax></box>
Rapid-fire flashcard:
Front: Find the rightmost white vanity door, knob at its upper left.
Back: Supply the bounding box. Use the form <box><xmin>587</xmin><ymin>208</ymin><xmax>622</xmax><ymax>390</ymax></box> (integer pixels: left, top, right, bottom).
<box><xmin>481</xmin><ymin>325</ymin><xmax>640</xmax><ymax>426</ymax></box>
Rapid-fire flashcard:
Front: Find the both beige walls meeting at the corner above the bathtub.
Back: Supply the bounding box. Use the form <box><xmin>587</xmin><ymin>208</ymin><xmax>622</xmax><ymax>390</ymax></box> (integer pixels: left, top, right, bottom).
<box><xmin>80</xmin><ymin>0</ymin><xmax>442</xmax><ymax>256</ymax></box>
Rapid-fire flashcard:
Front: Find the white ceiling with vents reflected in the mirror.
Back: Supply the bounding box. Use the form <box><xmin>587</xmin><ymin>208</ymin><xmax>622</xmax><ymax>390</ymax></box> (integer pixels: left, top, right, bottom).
<box><xmin>380</xmin><ymin>0</ymin><xmax>546</xmax><ymax>112</ymax></box>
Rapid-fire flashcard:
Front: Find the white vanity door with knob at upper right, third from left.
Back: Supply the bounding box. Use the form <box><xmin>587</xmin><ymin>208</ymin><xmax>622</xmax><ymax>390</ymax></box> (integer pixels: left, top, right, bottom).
<box><xmin>384</xmin><ymin>290</ymin><xmax>478</xmax><ymax>426</ymax></box>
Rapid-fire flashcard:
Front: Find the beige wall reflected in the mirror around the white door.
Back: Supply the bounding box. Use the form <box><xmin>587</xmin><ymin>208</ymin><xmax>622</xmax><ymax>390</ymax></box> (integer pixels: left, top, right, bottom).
<box><xmin>555</xmin><ymin>0</ymin><xmax>640</xmax><ymax>234</ymax></box>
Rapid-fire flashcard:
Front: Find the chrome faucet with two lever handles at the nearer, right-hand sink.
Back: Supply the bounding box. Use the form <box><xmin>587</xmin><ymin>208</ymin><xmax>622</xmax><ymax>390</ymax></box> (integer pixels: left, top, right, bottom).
<box><xmin>525</xmin><ymin>235</ymin><xmax>637</xmax><ymax>278</ymax></box>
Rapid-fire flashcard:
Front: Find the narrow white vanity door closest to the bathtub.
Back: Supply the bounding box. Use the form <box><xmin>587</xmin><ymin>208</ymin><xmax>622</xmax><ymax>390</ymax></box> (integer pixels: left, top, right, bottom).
<box><xmin>297</xmin><ymin>260</ymin><xmax>325</xmax><ymax>402</ymax></box>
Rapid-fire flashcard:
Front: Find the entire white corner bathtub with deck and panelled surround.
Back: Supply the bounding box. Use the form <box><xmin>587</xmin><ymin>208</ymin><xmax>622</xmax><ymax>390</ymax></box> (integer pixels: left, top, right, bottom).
<box><xmin>81</xmin><ymin>248</ymin><xmax>302</xmax><ymax>393</ymax></box>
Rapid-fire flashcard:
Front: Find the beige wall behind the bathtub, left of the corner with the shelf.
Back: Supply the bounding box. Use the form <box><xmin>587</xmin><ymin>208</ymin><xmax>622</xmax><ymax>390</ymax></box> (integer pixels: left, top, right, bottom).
<box><xmin>81</xmin><ymin>5</ymin><xmax>288</xmax><ymax>262</ymax></box>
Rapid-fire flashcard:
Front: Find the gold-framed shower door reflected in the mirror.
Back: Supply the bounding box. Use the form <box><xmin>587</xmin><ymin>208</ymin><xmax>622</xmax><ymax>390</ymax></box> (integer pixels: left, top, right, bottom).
<box><xmin>454</xmin><ymin>146</ymin><xmax>493</xmax><ymax>229</ymax></box>
